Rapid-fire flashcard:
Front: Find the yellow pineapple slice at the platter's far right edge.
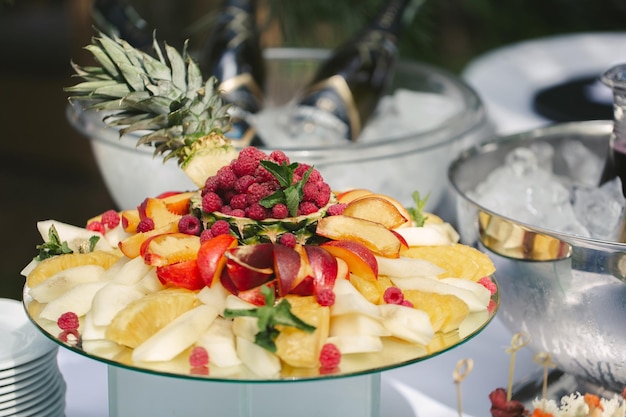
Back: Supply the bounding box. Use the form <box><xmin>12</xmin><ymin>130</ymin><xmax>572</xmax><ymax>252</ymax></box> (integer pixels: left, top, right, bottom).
<box><xmin>403</xmin><ymin>243</ymin><xmax>496</xmax><ymax>281</ymax></box>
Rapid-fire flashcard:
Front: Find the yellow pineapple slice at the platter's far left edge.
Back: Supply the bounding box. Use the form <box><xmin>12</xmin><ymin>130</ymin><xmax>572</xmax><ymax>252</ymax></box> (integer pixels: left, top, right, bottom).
<box><xmin>26</xmin><ymin>251</ymin><xmax>122</xmax><ymax>288</ymax></box>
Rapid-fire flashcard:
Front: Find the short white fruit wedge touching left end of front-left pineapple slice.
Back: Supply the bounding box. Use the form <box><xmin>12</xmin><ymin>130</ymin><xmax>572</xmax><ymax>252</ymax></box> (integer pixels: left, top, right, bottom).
<box><xmin>90</xmin><ymin>281</ymin><xmax>145</xmax><ymax>326</ymax></box>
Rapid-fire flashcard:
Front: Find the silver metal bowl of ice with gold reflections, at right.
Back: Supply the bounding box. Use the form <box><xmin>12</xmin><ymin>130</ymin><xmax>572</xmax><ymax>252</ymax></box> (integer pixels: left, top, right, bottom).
<box><xmin>448</xmin><ymin>121</ymin><xmax>626</xmax><ymax>392</ymax></box>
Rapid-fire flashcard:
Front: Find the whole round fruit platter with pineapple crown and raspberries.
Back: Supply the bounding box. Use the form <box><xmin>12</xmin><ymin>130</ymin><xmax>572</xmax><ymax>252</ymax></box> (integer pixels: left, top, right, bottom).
<box><xmin>22</xmin><ymin>31</ymin><xmax>499</xmax><ymax>381</ymax></box>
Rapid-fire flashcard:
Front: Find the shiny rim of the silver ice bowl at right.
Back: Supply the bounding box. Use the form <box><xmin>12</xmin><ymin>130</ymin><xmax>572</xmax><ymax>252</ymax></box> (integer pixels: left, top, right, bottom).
<box><xmin>448</xmin><ymin>120</ymin><xmax>626</xmax><ymax>252</ymax></box>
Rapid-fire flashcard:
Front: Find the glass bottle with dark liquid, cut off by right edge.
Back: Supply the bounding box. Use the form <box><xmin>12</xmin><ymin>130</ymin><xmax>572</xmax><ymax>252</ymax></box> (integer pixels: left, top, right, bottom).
<box><xmin>600</xmin><ymin>65</ymin><xmax>626</xmax><ymax>197</ymax></box>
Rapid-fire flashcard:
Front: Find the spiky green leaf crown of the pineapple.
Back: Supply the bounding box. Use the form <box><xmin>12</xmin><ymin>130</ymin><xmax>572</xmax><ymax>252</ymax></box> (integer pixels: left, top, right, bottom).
<box><xmin>65</xmin><ymin>32</ymin><xmax>230</xmax><ymax>163</ymax></box>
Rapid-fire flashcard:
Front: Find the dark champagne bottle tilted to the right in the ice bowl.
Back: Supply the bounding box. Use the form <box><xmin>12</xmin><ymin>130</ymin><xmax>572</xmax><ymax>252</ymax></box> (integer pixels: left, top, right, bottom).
<box><xmin>289</xmin><ymin>0</ymin><xmax>422</xmax><ymax>145</ymax></box>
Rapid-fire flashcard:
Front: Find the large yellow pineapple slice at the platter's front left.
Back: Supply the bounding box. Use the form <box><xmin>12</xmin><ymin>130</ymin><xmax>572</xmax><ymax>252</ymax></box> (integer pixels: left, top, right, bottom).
<box><xmin>106</xmin><ymin>289</ymin><xmax>201</xmax><ymax>348</ymax></box>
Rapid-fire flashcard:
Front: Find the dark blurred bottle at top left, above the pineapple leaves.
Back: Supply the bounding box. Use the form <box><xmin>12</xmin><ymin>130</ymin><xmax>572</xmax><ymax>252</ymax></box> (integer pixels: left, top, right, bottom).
<box><xmin>91</xmin><ymin>0</ymin><xmax>153</xmax><ymax>50</ymax></box>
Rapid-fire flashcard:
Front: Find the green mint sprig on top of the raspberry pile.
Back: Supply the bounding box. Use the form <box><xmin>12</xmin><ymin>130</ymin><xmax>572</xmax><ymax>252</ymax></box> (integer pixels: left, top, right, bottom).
<box><xmin>259</xmin><ymin>161</ymin><xmax>313</xmax><ymax>217</ymax></box>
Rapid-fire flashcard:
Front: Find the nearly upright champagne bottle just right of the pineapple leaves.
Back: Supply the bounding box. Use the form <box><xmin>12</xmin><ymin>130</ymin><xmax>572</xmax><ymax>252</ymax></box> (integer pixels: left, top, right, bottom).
<box><xmin>200</xmin><ymin>0</ymin><xmax>265</xmax><ymax>147</ymax></box>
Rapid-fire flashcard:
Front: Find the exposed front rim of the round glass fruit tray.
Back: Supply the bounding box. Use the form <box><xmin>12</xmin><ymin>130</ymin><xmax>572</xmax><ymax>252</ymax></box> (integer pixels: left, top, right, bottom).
<box><xmin>23</xmin><ymin>277</ymin><xmax>500</xmax><ymax>383</ymax></box>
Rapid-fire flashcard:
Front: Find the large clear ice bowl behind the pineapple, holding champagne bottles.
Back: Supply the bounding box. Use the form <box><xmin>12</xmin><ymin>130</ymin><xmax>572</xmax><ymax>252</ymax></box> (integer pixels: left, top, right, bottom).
<box><xmin>68</xmin><ymin>48</ymin><xmax>490</xmax><ymax>210</ymax></box>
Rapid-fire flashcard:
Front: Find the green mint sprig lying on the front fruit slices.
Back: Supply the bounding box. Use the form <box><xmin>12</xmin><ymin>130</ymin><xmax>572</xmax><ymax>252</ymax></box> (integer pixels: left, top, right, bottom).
<box><xmin>224</xmin><ymin>285</ymin><xmax>315</xmax><ymax>353</ymax></box>
